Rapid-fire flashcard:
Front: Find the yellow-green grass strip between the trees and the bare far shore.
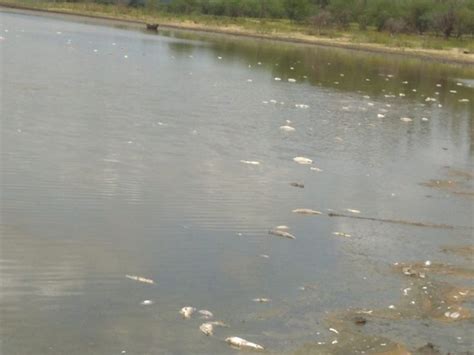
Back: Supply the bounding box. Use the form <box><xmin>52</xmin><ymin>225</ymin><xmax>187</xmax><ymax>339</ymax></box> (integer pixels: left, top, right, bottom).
<box><xmin>0</xmin><ymin>0</ymin><xmax>474</xmax><ymax>52</ymax></box>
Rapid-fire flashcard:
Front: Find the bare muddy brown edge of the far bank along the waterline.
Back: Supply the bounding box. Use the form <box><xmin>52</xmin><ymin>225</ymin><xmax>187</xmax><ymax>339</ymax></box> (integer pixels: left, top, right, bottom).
<box><xmin>0</xmin><ymin>1</ymin><xmax>474</xmax><ymax>66</ymax></box>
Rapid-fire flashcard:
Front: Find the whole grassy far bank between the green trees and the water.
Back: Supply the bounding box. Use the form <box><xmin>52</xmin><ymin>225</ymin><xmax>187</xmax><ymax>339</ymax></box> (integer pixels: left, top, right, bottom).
<box><xmin>0</xmin><ymin>0</ymin><xmax>474</xmax><ymax>64</ymax></box>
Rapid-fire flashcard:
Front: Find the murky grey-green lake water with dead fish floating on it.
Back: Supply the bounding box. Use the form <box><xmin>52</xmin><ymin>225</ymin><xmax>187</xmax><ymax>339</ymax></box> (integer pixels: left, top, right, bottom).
<box><xmin>0</xmin><ymin>12</ymin><xmax>474</xmax><ymax>354</ymax></box>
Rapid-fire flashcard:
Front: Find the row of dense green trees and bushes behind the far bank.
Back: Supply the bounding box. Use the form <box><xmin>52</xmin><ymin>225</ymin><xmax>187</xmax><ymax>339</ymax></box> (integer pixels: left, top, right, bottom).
<box><xmin>103</xmin><ymin>0</ymin><xmax>474</xmax><ymax>37</ymax></box>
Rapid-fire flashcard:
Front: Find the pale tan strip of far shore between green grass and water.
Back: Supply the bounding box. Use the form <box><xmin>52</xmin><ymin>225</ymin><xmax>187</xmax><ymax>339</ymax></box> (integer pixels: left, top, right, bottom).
<box><xmin>0</xmin><ymin>0</ymin><xmax>474</xmax><ymax>65</ymax></box>
